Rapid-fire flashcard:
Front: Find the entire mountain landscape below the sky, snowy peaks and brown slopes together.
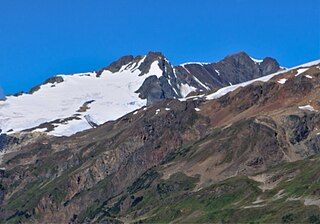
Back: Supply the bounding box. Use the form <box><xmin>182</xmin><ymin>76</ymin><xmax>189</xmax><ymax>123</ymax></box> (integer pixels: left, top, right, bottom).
<box><xmin>0</xmin><ymin>52</ymin><xmax>320</xmax><ymax>223</ymax></box>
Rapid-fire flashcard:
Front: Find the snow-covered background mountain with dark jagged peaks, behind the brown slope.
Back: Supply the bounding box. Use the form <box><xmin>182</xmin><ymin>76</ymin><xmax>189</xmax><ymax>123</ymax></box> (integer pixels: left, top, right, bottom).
<box><xmin>0</xmin><ymin>52</ymin><xmax>280</xmax><ymax>136</ymax></box>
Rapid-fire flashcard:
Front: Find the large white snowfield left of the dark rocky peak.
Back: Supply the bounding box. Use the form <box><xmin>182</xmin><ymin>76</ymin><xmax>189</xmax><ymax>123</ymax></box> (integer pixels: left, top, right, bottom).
<box><xmin>0</xmin><ymin>58</ymin><xmax>165</xmax><ymax>136</ymax></box>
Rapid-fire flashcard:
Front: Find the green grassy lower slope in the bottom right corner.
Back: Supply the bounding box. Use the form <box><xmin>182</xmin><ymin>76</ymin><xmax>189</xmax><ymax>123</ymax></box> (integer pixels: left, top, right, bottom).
<box><xmin>97</xmin><ymin>157</ymin><xmax>320</xmax><ymax>223</ymax></box>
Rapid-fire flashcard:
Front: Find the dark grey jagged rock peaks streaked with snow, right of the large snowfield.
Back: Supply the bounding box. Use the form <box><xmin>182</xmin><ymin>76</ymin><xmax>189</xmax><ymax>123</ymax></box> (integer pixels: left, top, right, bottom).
<box><xmin>97</xmin><ymin>52</ymin><xmax>280</xmax><ymax>105</ymax></box>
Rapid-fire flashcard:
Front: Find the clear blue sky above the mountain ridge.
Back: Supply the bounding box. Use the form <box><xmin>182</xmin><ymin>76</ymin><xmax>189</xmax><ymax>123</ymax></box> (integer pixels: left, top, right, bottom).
<box><xmin>0</xmin><ymin>0</ymin><xmax>320</xmax><ymax>94</ymax></box>
